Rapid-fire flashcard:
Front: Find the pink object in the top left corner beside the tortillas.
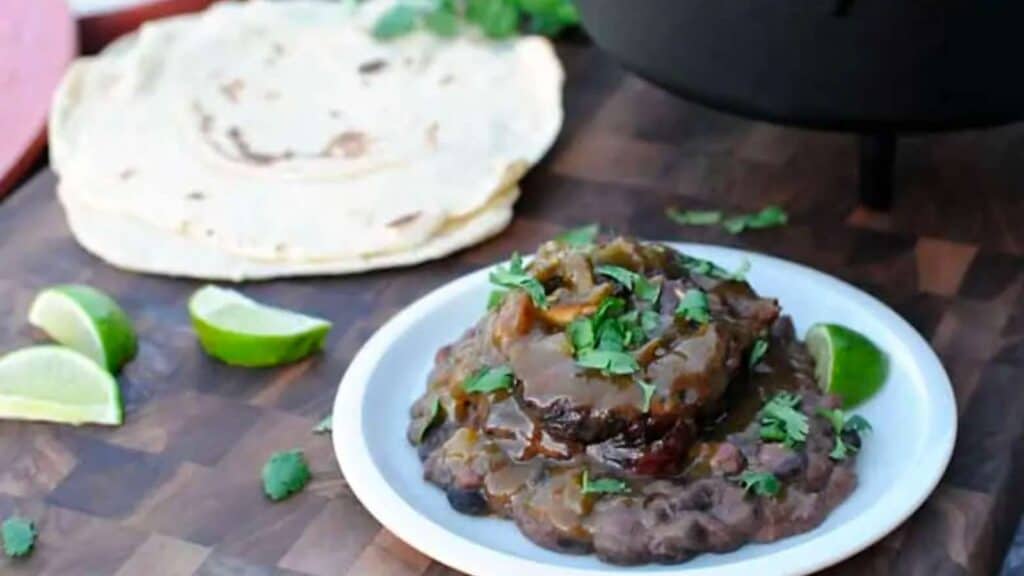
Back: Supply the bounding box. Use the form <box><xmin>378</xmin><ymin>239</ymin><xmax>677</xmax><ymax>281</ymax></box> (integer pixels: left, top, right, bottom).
<box><xmin>0</xmin><ymin>0</ymin><xmax>78</xmax><ymax>197</ymax></box>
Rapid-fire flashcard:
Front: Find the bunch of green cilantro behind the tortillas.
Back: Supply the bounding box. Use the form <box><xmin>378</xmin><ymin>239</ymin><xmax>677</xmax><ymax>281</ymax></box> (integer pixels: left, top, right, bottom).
<box><xmin>373</xmin><ymin>0</ymin><xmax>580</xmax><ymax>40</ymax></box>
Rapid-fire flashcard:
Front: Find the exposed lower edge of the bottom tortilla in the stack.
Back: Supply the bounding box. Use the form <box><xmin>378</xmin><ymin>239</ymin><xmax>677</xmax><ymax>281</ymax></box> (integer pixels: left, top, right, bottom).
<box><xmin>65</xmin><ymin>187</ymin><xmax>519</xmax><ymax>282</ymax></box>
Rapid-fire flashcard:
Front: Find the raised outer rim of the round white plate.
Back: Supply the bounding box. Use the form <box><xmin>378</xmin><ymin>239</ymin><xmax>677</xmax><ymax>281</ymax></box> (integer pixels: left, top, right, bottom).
<box><xmin>332</xmin><ymin>242</ymin><xmax>958</xmax><ymax>576</ymax></box>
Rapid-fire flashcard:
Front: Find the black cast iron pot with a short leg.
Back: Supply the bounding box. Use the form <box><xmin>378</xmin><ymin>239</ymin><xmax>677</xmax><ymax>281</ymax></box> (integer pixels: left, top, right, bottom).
<box><xmin>577</xmin><ymin>0</ymin><xmax>1024</xmax><ymax>206</ymax></box>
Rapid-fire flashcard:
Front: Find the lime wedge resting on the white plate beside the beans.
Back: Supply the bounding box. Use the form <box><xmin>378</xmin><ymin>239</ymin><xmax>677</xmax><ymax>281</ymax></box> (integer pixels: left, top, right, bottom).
<box><xmin>806</xmin><ymin>324</ymin><xmax>889</xmax><ymax>408</ymax></box>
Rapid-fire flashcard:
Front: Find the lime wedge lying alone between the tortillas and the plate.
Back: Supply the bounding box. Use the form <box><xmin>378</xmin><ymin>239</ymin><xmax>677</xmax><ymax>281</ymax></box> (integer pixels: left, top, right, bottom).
<box><xmin>188</xmin><ymin>286</ymin><xmax>331</xmax><ymax>366</ymax></box>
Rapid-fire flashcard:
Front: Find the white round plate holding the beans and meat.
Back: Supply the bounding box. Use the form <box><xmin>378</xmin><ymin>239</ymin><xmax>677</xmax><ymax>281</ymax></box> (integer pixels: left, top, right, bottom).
<box><xmin>334</xmin><ymin>244</ymin><xmax>956</xmax><ymax>576</ymax></box>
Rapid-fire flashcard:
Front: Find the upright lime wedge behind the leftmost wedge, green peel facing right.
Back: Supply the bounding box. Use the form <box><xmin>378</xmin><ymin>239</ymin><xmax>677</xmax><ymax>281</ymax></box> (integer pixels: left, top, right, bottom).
<box><xmin>29</xmin><ymin>285</ymin><xmax>138</xmax><ymax>373</ymax></box>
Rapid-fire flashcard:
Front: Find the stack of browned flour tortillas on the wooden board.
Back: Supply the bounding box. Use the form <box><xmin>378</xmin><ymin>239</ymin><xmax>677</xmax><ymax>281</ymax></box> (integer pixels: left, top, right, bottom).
<box><xmin>50</xmin><ymin>0</ymin><xmax>563</xmax><ymax>280</ymax></box>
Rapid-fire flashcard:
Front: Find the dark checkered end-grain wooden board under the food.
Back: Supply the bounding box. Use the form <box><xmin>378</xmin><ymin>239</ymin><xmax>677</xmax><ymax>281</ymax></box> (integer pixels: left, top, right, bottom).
<box><xmin>0</xmin><ymin>45</ymin><xmax>1024</xmax><ymax>576</ymax></box>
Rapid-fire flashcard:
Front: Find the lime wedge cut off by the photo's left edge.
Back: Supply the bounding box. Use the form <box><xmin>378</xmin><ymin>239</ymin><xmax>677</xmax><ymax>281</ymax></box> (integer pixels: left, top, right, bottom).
<box><xmin>0</xmin><ymin>344</ymin><xmax>124</xmax><ymax>424</ymax></box>
